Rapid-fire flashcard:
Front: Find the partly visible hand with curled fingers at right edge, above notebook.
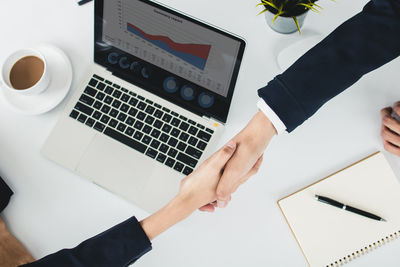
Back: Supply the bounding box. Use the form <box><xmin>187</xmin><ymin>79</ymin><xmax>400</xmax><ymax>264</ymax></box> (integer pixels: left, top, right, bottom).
<box><xmin>381</xmin><ymin>102</ymin><xmax>400</xmax><ymax>156</ymax></box>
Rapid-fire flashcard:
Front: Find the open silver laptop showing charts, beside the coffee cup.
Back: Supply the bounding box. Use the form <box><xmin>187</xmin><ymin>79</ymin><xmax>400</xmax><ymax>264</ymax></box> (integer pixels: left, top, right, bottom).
<box><xmin>41</xmin><ymin>0</ymin><xmax>245</xmax><ymax>212</ymax></box>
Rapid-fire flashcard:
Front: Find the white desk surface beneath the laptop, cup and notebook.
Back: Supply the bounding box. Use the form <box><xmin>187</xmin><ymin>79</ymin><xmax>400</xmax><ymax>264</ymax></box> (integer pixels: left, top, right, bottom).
<box><xmin>0</xmin><ymin>0</ymin><xmax>400</xmax><ymax>267</ymax></box>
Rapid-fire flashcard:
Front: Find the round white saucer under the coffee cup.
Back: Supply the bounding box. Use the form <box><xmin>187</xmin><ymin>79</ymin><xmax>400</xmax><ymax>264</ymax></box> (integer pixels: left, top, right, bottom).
<box><xmin>1</xmin><ymin>44</ymin><xmax>72</xmax><ymax>115</ymax></box>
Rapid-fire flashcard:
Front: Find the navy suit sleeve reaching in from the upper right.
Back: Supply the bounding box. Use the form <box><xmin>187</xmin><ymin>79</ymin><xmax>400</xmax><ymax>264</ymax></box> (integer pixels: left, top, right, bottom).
<box><xmin>258</xmin><ymin>0</ymin><xmax>400</xmax><ymax>132</ymax></box>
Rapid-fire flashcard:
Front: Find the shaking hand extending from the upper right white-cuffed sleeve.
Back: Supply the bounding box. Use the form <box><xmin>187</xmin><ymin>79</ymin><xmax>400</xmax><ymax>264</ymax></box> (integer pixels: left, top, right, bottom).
<box><xmin>211</xmin><ymin>111</ymin><xmax>276</xmax><ymax>211</ymax></box>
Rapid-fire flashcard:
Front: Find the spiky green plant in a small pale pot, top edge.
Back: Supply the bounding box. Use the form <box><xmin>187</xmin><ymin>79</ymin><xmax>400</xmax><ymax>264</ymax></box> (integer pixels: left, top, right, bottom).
<box><xmin>257</xmin><ymin>0</ymin><xmax>322</xmax><ymax>34</ymax></box>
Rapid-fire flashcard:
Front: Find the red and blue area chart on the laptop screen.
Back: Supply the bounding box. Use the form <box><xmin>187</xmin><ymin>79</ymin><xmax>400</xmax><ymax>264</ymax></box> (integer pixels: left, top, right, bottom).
<box><xmin>127</xmin><ymin>23</ymin><xmax>211</xmax><ymax>70</ymax></box>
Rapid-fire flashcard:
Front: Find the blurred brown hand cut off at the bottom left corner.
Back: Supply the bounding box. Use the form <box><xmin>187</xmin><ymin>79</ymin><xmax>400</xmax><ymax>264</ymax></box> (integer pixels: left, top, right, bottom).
<box><xmin>0</xmin><ymin>219</ymin><xmax>35</xmax><ymax>267</ymax></box>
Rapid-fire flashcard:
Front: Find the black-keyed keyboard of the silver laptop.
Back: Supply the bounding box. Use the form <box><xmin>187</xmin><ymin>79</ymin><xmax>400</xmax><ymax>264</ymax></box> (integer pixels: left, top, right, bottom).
<box><xmin>70</xmin><ymin>75</ymin><xmax>214</xmax><ymax>175</ymax></box>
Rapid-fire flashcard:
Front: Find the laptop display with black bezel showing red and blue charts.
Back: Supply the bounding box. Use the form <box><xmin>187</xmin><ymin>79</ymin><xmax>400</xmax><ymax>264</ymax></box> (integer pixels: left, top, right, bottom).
<box><xmin>95</xmin><ymin>0</ymin><xmax>245</xmax><ymax>122</ymax></box>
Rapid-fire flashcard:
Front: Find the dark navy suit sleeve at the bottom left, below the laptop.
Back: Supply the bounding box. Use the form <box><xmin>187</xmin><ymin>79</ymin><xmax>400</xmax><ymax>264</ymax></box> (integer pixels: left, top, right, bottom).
<box><xmin>23</xmin><ymin>217</ymin><xmax>151</xmax><ymax>267</ymax></box>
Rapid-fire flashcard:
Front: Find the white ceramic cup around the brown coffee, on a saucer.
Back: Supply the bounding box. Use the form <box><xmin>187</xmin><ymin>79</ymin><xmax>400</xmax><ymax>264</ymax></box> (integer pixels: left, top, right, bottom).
<box><xmin>0</xmin><ymin>49</ymin><xmax>50</xmax><ymax>95</ymax></box>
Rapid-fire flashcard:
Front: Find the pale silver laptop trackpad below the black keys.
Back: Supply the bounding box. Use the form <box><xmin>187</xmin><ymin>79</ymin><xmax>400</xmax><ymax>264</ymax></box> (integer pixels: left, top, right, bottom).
<box><xmin>77</xmin><ymin>135</ymin><xmax>155</xmax><ymax>207</ymax></box>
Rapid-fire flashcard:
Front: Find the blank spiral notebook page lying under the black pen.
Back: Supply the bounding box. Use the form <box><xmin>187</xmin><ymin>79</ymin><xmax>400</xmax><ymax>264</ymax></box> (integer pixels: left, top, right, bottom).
<box><xmin>278</xmin><ymin>152</ymin><xmax>400</xmax><ymax>267</ymax></box>
